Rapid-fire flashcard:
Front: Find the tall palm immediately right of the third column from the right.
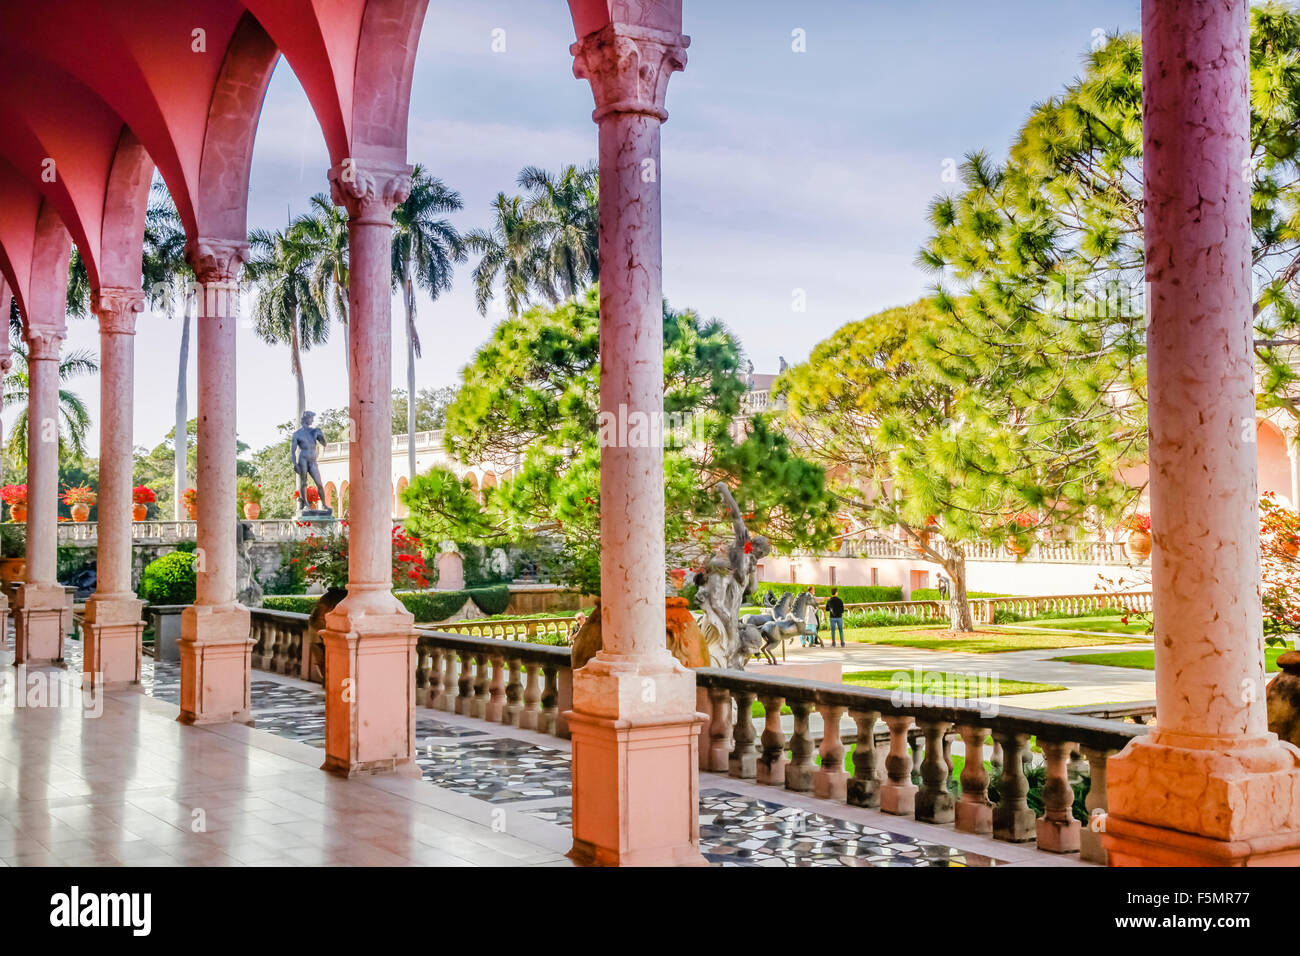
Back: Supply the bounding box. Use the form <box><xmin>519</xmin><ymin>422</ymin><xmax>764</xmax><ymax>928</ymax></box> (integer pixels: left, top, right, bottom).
<box><xmin>393</xmin><ymin>164</ymin><xmax>465</xmax><ymax>479</ymax></box>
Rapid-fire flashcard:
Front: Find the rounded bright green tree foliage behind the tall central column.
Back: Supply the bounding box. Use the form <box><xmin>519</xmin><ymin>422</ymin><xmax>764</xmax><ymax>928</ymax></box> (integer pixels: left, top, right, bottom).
<box><xmin>416</xmin><ymin>287</ymin><xmax>832</xmax><ymax>593</ymax></box>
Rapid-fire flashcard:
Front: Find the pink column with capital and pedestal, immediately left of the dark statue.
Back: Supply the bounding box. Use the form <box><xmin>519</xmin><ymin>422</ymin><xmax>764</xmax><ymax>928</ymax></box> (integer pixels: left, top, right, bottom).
<box><xmin>179</xmin><ymin>239</ymin><xmax>255</xmax><ymax>723</ymax></box>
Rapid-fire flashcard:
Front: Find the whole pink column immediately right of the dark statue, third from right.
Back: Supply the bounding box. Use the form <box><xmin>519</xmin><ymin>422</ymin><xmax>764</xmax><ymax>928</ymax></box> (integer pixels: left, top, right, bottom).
<box><xmin>321</xmin><ymin>160</ymin><xmax>420</xmax><ymax>777</ymax></box>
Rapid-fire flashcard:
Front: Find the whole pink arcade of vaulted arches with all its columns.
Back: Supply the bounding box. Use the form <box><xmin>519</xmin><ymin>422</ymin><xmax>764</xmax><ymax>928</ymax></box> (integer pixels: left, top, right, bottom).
<box><xmin>0</xmin><ymin>0</ymin><xmax>1300</xmax><ymax>865</ymax></box>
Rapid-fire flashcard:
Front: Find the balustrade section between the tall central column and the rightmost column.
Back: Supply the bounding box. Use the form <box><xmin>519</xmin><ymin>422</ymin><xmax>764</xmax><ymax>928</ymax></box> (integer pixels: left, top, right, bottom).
<box><xmin>696</xmin><ymin>669</ymin><xmax>1147</xmax><ymax>862</ymax></box>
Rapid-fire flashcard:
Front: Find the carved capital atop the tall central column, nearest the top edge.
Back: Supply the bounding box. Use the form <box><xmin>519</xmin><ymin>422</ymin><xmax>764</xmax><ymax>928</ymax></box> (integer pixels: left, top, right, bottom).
<box><xmin>569</xmin><ymin>23</ymin><xmax>690</xmax><ymax>122</ymax></box>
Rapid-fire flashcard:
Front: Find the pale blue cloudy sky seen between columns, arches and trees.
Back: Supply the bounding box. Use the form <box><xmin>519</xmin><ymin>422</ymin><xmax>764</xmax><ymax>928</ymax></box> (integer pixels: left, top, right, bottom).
<box><xmin>69</xmin><ymin>0</ymin><xmax>1140</xmax><ymax>447</ymax></box>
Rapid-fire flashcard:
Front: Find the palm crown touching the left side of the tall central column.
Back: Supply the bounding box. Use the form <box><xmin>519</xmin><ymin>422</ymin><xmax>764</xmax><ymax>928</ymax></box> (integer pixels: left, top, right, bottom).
<box><xmin>519</xmin><ymin>163</ymin><xmax>601</xmax><ymax>302</ymax></box>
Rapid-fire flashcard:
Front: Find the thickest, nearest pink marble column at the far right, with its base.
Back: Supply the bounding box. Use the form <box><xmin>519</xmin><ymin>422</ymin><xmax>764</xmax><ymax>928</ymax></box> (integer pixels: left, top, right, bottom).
<box><xmin>1104</xmin><ymin>0</ymin><xmax>1300</xmax><ymax>865</ymax></box>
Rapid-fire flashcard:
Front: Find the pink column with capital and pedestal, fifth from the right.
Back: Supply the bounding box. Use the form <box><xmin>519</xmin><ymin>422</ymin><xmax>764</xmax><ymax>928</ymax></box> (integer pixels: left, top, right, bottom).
<box><xmin>82</xmin><ymin>289</ymin><xmax>144</xmax><ymax>687</ymax></box>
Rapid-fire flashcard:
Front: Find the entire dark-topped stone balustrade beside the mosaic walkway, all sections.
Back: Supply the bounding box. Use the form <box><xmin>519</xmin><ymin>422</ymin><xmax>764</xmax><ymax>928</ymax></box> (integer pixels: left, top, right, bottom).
<box><xmin>241</xmin><ymin>610</ymin><xmax>1147</xmax><ymax>862</ymax></box>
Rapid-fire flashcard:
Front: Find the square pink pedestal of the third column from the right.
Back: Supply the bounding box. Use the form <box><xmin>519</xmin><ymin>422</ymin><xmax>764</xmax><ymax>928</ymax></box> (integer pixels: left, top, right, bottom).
<box><xmin>321</xmin><ymin>592</ymin><xmax>420</xmax><ymax>777</ymax></box>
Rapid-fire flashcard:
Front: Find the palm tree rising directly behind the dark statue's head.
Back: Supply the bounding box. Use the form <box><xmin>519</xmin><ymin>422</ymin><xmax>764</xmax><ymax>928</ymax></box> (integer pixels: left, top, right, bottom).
<box><xmin>244</xmin><ymin>226</ymin><xmax>329</xmax><ymax>421</ymax></box>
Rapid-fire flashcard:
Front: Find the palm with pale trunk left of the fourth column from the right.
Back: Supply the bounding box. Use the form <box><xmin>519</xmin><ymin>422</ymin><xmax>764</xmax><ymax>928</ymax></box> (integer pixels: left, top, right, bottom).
<box><xmin>144</xmin><ymin>178</ymin><xmax>195</xmax><ymax>520</ymax></box>
